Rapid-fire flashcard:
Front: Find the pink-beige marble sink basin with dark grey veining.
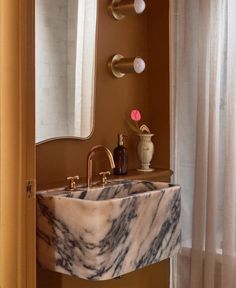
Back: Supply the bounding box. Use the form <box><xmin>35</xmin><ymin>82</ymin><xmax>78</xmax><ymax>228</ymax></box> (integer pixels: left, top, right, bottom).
<box><xmin>37</xmin><ymin>180</ymin><xmax>181</xmax><ymax>280</ymax></box>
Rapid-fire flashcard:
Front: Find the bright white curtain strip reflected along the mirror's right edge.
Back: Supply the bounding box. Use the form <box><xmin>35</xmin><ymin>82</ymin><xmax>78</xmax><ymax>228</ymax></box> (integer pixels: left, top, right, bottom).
<box><xmin>74</xmin><ymin>0</ymin><xmax>97</xmax><ymax>137</ymax></box>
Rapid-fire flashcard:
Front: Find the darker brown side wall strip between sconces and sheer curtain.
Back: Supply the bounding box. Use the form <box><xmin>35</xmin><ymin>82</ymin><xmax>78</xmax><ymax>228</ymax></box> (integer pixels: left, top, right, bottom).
<box><xmin>147</xmin><ymin>0</ymin><xmax>170</xmax><ymax>168</ymax></box>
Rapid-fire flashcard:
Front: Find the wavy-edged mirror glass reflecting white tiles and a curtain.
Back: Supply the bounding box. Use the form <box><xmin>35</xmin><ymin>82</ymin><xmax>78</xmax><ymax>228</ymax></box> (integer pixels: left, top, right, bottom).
<box><xmin>36</xmin><ymin>0</ymin><xmax>97</xmax><ymax>142</ymax></box>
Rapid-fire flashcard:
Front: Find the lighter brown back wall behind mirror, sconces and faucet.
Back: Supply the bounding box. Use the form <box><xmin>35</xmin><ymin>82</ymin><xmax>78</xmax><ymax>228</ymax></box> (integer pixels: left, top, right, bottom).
<box><xmin>37</xmin><ymin>0</ymin><xmax>148</xmax><ymax>184</ymax></box>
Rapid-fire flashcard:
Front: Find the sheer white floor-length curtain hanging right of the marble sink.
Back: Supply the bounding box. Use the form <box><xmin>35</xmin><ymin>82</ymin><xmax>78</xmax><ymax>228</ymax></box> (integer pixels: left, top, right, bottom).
<box><xmin>170</xmin><ymin>0</ymin><xmax>236</xmax><ymax>288</ymax></box>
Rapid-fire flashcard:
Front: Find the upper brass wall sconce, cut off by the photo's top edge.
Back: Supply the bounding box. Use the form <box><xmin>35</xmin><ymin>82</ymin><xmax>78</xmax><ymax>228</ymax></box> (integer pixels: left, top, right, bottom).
<box><xmin>108</xmin><ymin>0</ymin><xmax>146</xmax><ymax>20</ymax></box>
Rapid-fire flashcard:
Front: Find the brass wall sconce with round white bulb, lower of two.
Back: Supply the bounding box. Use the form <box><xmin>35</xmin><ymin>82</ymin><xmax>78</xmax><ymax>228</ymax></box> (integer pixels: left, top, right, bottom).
<box><xmin>108</xmin><ymin>54</ymin><xmax>145</xmax><ymax>78</ymax></box>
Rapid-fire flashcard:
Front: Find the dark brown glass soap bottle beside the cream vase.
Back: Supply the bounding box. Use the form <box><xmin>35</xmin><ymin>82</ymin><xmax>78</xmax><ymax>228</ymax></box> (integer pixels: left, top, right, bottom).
<box><xmin>113</xmin><ymin>134</ymin><xmax>128</xmax><ymax>175</ymax></box>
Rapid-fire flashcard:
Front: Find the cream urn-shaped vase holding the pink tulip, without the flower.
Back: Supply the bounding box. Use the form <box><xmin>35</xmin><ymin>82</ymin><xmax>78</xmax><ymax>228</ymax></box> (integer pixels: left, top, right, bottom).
<box><xmin>137</xmin><ymin>134</ymin><xmax>154</xmax><ymax>172</ymax></box>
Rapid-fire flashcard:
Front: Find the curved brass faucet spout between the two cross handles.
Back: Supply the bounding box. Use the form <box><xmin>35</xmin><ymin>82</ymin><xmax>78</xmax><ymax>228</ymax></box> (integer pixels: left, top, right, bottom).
<box><xmin>87</xmin><ymin>145</ymin><xmax>115</xmax><ymax>187</ymax></box>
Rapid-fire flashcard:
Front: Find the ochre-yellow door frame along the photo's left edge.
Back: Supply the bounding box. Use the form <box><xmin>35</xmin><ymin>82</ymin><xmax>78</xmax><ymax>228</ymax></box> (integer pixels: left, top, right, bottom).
<box><xmin>0</xmin><ymin>0</ymin><xmax>36</xmax><ymax>288</ymax></box>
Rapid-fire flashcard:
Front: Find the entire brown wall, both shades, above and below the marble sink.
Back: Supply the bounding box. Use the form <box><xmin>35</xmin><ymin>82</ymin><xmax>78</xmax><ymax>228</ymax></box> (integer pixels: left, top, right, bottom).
<box><xmin>37</xmin><ymin>0</ymin><xmax>169</xmax><ymax>288</ymax></box>
